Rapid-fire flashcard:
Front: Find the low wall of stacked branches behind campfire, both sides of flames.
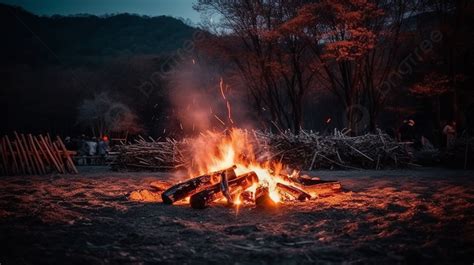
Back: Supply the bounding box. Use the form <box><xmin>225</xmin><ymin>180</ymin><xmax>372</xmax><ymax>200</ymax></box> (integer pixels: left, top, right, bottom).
<box><xmin>113</xmin><ymin>130</ymin><xmax>413</xmax><ymax>170</ymax></box>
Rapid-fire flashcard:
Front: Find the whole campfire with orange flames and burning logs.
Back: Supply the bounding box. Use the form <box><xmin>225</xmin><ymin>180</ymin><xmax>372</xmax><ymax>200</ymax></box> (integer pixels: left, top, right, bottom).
<box><xmin>162</xmin><ymin>129</ymin><xmax>341</xmax><ymax>209</ymax></box>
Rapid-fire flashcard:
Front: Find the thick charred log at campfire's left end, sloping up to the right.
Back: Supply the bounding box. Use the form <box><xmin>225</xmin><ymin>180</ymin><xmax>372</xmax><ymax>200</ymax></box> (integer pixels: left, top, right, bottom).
<box><xmin>161</xmin><ymin>166</ymin><xmax>235</xmax><ymax>204</ymax></box>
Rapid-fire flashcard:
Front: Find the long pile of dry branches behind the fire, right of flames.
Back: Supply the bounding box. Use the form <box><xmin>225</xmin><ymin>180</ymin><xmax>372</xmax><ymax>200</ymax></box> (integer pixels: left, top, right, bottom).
<box><xmin>254</xmin><ymin>130</ymin><xmax>413</xmax><ymax>170</ymax></box>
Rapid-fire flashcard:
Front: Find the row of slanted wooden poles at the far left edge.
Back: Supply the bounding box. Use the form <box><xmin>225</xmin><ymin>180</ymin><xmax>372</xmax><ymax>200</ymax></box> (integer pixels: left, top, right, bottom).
<box><xmin>0</xmin><ymin>132</ymin><xmax>78</xmax><ymax>176</ymax></box>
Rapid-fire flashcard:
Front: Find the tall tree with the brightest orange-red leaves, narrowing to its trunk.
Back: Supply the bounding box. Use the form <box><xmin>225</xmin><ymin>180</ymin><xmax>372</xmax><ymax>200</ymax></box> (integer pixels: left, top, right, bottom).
<box><xmin>287</xmin><ymin>0</ymin><xmax>412</xmax><ymax>132</ymax></box>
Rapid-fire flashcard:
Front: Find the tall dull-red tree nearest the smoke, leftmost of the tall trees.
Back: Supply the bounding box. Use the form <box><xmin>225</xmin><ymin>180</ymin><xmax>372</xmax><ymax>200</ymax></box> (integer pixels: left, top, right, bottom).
<box><xmin>196</xmin><ymin>0</ymin><xmax>320</xmax><ymax>133</ymax></box>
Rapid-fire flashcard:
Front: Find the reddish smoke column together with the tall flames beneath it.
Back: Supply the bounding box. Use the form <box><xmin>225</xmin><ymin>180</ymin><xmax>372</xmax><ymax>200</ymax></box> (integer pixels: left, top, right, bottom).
<box><xmin>167</xmin><ymin>58</ymin><xmax>272</xmax><ymax>180</ymax></box>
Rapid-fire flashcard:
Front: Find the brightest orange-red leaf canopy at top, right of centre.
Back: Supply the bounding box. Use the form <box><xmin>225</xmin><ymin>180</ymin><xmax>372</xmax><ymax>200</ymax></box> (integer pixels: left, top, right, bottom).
<box><xmin>281</xmin><ymin>0</ymin><xmax>383</xmax><ymax>61</ymax></box>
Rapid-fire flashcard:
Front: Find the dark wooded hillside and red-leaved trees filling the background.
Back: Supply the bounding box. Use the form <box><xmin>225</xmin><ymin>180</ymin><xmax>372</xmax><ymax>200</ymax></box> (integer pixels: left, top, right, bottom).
<box><xmin>0</xmin><ymin>0</ymin><xmax>474</xmax><ymax>146</ymax></box>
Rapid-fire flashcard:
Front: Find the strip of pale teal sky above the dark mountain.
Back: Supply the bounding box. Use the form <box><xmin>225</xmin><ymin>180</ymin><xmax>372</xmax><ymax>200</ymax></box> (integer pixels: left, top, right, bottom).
<box><xmin>0</xmin><ymin>0</ymin><xmax>199</xmax><ymax>23</ymax></box>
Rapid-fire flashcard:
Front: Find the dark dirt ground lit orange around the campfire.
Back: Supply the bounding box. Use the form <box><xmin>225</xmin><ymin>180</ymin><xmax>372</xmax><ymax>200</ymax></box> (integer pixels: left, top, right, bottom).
<box><xmin>0</xmin><ymin>168</ymin><xmax>474</xmax><ymax>265</ymax></box>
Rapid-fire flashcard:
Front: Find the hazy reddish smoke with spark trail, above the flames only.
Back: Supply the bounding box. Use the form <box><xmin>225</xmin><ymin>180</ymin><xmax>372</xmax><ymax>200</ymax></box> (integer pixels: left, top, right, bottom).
<box><xmin>168</xmin><ymin>59</ymin><xmax>249</xmax><ymax>136</ymax></box>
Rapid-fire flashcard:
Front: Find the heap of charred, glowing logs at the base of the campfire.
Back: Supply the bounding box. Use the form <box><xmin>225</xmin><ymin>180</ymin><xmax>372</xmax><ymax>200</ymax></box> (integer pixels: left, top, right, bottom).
<box><xmin>161</xmin><ymin>166</ymin><xmax>341</xmax><ymax>209</ymax></box>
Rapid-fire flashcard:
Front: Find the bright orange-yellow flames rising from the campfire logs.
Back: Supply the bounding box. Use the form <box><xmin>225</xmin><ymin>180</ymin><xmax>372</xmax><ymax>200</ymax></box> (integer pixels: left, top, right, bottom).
<box><xmin>190</xmin><ymin>128</ymin><xmax>289</xmax><ymax>204</ymax></box>
